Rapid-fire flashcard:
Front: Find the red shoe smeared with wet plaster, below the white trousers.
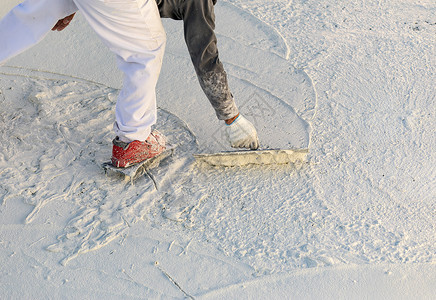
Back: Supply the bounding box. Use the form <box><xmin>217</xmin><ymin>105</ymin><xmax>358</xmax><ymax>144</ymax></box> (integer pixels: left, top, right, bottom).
<box><xmin>112</xmin><ymin>130</ymin><xmax>166</xmax><ymax>168</ymax></box>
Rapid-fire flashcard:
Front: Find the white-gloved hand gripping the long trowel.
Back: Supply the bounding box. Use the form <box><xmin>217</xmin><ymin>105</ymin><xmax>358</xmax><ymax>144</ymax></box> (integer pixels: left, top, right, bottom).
<box><xmin>226</xmin><ymin>115</ymin><xmax>259</xmax><ymax>150</ymax></box>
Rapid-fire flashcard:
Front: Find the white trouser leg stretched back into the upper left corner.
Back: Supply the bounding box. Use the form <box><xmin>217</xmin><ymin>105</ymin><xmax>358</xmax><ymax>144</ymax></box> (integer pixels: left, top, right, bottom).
<box><xmin>0</xmin><ymin>0</ymin><xmax>77</xmax><ymax>65</ymax></box>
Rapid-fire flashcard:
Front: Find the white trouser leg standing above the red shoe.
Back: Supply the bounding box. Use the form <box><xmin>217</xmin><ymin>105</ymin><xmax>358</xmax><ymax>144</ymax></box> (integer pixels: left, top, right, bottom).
<box><xmin>74</xmin><ymin>0</ymin><xmax>166</xmax><ymax>141</ymax></box>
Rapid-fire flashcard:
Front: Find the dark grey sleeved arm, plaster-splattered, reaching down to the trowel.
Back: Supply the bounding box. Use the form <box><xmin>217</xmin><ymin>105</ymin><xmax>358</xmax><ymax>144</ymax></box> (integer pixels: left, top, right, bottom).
<box><xmin>156</xmin><ymin>0</ymin><xmax>238</xmax><ymax>120</ymax></box>
